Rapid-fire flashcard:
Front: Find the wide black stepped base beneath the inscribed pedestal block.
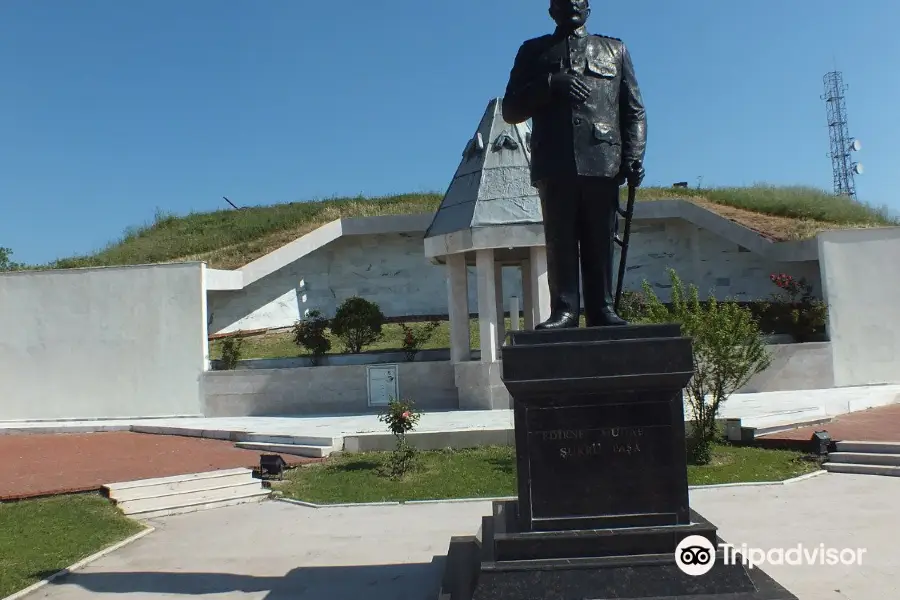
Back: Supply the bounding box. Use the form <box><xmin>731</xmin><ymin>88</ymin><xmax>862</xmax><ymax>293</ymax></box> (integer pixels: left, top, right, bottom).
<box><xmin>439</xmin><ymin>501</ymin><xmax>797</xmax><ymax>600</ymax></box>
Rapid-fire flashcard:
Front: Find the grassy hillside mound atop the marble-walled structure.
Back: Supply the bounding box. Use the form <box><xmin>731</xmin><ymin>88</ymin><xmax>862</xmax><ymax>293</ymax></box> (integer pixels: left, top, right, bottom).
<box><xmin>51</xmin><ymin>185</ymin><xmax>898</xmax><ymax>269</ymax></box>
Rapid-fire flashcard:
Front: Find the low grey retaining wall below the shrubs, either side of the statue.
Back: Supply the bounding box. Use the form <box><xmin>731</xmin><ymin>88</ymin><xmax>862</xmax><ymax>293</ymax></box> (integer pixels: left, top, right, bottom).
<box><xmin>204</xmin><ymin>342</ymin><xmax>832</xmax><ymax>417</ymax></box>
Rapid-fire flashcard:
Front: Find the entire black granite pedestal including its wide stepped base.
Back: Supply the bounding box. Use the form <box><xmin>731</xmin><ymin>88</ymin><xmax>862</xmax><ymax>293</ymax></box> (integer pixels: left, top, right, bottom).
<box><xmin>439</xmin><ymin>325</ymin><xmax>796</xmax><ymax>600</ymax></box>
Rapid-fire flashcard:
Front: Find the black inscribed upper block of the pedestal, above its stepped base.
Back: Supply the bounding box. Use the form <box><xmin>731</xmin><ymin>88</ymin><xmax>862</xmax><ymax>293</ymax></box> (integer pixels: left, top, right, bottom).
<box><xmin>503</xmin><ymin>325</ymin><xmax>693</xmax><ymax>531</ymax></box>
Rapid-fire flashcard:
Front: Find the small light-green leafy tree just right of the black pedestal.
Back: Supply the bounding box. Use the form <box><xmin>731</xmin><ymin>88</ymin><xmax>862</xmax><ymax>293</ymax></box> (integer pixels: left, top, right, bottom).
<box><xmin>643</xmin><ymin>269</ymin><xmax>771</xmax><ymax>464</ymax></box>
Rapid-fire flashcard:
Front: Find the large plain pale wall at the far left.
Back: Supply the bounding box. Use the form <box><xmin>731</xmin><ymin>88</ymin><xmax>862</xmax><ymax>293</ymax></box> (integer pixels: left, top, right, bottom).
<box><xmin>0</xmin><ymin>263</ymin><xmax>208</xmax><ymax>420</ymax></box>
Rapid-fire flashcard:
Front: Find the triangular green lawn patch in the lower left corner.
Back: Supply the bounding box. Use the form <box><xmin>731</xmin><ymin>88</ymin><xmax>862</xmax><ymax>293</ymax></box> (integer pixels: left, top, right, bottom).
<box><xmin>0</xmin><ymin>494</ymin><xmax>142</xmax><ymax>598</ymax></box>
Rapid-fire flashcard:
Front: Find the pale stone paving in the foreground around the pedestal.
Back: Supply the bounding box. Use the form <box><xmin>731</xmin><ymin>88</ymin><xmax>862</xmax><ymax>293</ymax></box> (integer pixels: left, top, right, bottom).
<box><xmin>24</xmin><ymin>474</ymin><xmax>900</xmax><ymax>600</ymax></box>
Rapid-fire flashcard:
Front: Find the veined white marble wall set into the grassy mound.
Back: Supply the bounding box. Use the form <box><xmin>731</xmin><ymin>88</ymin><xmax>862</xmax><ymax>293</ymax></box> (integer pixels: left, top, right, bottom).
<box><xmin>209</xmin><ymin>220</ymin><xmax>820</xmax><ymax>333</ymax></box>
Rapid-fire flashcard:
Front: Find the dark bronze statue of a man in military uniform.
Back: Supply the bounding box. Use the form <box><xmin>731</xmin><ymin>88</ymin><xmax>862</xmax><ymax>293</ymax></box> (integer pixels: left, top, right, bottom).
<box><xmin>503</xmin><ymin>0</ymin><xmax>647</xmax><ymax>329</ymax></box>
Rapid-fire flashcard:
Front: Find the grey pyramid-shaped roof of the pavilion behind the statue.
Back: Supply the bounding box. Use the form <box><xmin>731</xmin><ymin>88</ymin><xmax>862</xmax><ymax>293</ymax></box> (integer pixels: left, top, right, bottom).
<box><xmin>425</xmin><ymin>98</ymin><xmax>543</xmax><ymax>238</ymax></box>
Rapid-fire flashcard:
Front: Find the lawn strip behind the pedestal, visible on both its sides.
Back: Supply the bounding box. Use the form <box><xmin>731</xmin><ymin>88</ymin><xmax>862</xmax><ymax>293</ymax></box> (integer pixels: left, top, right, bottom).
<box><xmin>276</xmin><ymin>445</ymin><xmax>818</xmax><ymax>504</ymax></box>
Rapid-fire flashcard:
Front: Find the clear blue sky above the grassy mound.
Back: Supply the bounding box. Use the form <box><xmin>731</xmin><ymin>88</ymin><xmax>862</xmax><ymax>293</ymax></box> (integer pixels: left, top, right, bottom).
<box><xmin>0</xmin><ymin>0</ymin><xmax>900</xmax><ymax>263</ymax></box>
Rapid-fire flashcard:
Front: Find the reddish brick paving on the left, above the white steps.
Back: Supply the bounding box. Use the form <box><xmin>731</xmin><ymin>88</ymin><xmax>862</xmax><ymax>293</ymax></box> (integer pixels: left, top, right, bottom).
<box><xmin>0</xmin><ymin>432</ymin><xmax>321</xmax><ymax>500</ymax></box>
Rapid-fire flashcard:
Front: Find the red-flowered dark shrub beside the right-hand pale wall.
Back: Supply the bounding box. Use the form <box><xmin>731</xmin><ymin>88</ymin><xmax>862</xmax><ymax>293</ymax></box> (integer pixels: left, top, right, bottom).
<box><xmin>763</xmin><ymin>273</ymin><xmax>828</xmax><ymax>342</ymax></box>
